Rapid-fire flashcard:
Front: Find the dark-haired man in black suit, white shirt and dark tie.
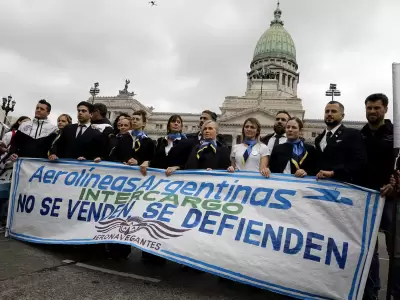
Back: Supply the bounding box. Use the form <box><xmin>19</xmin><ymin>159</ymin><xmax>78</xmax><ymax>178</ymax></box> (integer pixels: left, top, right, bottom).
<box><xmin>49</xmin><ymin>101</ymin><xmax>105</xmax><ymax>162</ymax></box>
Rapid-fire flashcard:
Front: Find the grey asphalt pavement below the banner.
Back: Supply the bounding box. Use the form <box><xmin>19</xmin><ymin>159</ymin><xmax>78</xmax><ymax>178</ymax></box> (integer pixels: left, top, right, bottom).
<box><xmin>0</xmin><ymin>235</ymin><xmax>388</xmax><ymax>300</ymax></box>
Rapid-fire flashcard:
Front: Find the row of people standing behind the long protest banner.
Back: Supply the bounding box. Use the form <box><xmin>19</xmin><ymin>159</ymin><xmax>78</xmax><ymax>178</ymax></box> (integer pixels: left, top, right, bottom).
<box><xmin>0</xmin><ymin>94</ymin><xmax>400</xmax><ymax>299</ymax></box>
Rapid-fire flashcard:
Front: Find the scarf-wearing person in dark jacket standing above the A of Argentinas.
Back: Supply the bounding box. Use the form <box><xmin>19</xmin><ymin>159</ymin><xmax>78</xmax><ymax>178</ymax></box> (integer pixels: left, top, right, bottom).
<box><xmin>124</xmin><ymin>110</ymin><xmax>155</xmax><ymax>175</ymax></box>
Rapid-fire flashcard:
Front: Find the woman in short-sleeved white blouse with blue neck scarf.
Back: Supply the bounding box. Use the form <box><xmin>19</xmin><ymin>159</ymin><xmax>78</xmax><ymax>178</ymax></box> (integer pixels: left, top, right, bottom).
<box><xmin>228</xmin><ymin>118</ymin><xmax>269</xmax><ymax>176</ymax></box>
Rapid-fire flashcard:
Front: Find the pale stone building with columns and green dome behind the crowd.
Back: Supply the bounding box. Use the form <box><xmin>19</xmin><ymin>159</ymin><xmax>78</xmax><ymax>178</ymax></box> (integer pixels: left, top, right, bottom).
<box><xmin>96</xmin><ymin>2</ymin><xmax>364</xmax><ymax>146</ymax></box>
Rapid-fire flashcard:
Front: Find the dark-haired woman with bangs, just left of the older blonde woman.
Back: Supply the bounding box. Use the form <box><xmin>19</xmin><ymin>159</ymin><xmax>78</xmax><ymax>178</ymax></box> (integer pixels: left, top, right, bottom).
<box><xmin>150</xmin><ymin>115</ymin><xmax>192</xmax><ymax>176</ymax></box>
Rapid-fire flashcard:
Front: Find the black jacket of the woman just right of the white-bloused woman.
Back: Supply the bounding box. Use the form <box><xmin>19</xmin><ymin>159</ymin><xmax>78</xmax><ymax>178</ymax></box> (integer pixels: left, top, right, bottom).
<box><xmin>269</xmin><ymin>143</ymin><xmax>317</xmax><ymax>176</ymax></box>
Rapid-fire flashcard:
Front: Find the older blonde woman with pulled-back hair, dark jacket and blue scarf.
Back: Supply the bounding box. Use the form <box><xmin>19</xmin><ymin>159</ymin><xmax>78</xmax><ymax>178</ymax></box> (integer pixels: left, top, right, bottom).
<box><xmin>185</xmin><ymin>121</ymin><xmax>230</xmax><ymax>171</ymax></box>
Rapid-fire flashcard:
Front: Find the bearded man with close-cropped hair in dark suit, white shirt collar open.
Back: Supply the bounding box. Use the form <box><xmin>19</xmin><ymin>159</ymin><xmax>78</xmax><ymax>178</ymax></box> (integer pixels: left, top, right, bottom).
<box><xmin>315</xmin><ymin>101</ymin><xmax>367</xmax><ymax>184</ymax></box>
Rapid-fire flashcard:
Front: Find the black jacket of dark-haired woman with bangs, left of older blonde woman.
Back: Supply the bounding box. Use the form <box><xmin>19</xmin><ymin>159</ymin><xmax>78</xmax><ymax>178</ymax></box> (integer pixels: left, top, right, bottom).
<box><xmin>150</xmin><ymin>137</ymin><xmax>193</xmax><ymax>169</ymax></box>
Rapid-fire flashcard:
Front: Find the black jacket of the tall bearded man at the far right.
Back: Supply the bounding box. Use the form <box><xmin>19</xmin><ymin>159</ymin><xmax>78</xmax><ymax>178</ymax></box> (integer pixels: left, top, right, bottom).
<box><xmin>361</xmin><ymin>120</ymin><xmax>395</xmax><ymax>190</ymax></box>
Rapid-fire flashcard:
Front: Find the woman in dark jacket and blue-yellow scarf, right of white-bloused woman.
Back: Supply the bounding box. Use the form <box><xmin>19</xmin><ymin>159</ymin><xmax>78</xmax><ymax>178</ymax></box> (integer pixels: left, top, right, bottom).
<box><xmin>269</xmin><ymin>118</ymin><xmax>316</xmax><ymax>177</ymax></box>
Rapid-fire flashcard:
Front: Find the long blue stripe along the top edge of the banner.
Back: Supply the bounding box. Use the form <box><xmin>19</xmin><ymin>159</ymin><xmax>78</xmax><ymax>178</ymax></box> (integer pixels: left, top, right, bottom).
<box><xmin>24</xmin><ymin>158</ymin><xmax>375</xmax><ymax>192</ymax></box>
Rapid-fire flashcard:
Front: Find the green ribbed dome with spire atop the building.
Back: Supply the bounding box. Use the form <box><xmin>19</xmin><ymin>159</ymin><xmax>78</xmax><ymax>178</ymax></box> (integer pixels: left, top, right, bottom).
<box><xmin>253</xmin><ymin>6</ymin><xmax>296</xmax><ymax>62</ymax></box>
